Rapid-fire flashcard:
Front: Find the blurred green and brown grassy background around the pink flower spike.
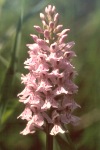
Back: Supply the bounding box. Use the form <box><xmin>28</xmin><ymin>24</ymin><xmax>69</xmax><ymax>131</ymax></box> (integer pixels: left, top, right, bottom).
<box><xmin>0</xmin><ymin>0</ymin><xmax>100</xmax><ymax>150</ymax></box>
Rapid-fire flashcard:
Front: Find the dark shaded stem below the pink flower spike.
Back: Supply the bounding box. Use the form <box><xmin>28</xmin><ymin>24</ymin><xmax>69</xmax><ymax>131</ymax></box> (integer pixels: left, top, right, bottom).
<box><xmin>46</xmin><ymin>123</ymin><xmax>53</xmax><ymax>150</ymax></box>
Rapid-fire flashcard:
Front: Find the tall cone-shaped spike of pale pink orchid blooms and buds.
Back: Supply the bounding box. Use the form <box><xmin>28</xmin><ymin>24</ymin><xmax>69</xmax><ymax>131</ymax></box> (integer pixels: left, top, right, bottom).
<box><xmin>18</xmin><ymin>5</ymin><xmax>79</xmax><ymax>135</ymax></box>
